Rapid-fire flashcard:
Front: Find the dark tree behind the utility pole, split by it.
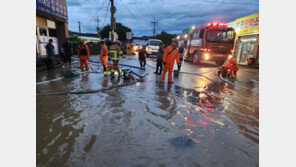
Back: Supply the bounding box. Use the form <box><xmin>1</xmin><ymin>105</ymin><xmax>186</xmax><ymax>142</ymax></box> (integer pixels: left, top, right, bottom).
<box><xmin>100</xmin><ymin>23</ymin><xmax>132</xmax><ymax>41</ymax></box>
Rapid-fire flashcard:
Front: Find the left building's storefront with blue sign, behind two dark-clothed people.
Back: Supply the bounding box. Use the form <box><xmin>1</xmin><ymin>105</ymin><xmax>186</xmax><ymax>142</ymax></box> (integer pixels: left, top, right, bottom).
<box><xmin>36</xmin><ymin>0</ymin><xmax>69</xmax><ymax>58</ymax></box>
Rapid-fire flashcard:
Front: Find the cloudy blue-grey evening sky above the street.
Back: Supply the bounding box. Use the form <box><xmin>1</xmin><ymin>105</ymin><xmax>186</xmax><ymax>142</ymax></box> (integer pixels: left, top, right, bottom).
<box><xmin>67</xmin><ymin>0</ymin><xmax>259</xmax><ymax>36</ymax></box>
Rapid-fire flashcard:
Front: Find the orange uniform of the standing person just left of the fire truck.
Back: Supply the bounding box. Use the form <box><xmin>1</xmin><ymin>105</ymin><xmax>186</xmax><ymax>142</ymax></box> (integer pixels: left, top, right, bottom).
<box><xmin>161</xmin><ymin>45</ymin><xmax>180</xmax><ymax>82</ymax></box>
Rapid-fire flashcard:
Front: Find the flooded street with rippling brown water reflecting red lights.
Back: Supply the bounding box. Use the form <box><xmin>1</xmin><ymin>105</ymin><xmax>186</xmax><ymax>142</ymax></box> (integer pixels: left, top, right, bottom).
<box><xmin>36</xmin><ymin>56</ymin><xmax>259</xmax><ymax>167</ymax></box>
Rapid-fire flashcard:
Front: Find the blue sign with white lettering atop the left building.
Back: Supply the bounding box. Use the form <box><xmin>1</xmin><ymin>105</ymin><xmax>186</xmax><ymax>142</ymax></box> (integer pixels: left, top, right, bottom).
<box><xmin>36</xmin><ymin>0</ymin><xmax>68</xmax><ymax>20</ymax></box>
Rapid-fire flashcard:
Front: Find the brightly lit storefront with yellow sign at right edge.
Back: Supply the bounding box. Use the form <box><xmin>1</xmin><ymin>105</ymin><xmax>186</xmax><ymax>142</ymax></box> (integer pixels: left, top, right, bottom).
<box><xmin>234</xmin><ymin>13</ymin><xmax>259</xmax><ymax>65</ymax></box>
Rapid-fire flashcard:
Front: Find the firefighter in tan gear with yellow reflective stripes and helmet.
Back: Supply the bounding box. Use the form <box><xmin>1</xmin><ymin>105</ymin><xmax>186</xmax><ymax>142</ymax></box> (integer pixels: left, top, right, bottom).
<box><xmin>108</xmin><ymin>41</ymin><xmax>125</xmax><ymax>78</ymax></box>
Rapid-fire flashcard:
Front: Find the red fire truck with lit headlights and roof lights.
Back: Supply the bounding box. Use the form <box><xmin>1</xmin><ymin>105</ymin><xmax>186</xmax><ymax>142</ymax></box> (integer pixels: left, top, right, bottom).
<box><xmin>183</xmin><ymin>22</ymin><xmax>235</xmax><ymax>65</ymax></box>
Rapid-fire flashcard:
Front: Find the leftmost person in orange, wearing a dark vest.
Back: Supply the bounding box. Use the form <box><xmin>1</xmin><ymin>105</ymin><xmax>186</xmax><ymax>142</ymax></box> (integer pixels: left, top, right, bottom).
<box><xmin>78</xmin><ymin>39</ymin><xmax>89</xmax><ymax>71</ymax></box>
